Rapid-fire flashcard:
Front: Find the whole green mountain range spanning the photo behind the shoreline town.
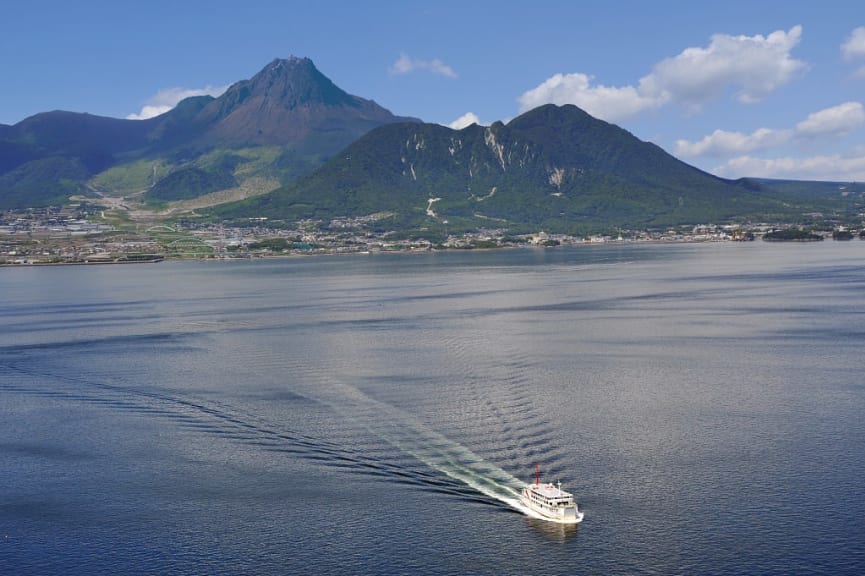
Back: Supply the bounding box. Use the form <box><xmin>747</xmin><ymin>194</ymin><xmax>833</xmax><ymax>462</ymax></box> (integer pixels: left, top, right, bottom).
<box><xmin>8</xmin><ymin>58</ymin><xmax>865</xmax><ymax>234</ymax></box>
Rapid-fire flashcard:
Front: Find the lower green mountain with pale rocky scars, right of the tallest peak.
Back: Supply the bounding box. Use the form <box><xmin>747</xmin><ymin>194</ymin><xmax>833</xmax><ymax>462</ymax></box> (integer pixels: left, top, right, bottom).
<box><xmin>215</xmin><ymin>105</ymin><xmax>808</xmax><ymax>232</ymax></box>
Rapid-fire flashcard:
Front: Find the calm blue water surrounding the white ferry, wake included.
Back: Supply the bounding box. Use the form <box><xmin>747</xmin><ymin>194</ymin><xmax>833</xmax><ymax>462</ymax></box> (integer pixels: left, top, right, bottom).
<box><xmin>0</xmin><ymin>241</ymin><xmax>865</xmax><ymax>575</ymax></box>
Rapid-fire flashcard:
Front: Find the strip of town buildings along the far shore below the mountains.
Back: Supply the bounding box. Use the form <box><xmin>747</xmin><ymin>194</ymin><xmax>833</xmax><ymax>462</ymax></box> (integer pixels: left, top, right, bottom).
<box><xmin>0</xmin><ymin>205</ymin><xmax>862</xmax><ymax>264</ymax></box>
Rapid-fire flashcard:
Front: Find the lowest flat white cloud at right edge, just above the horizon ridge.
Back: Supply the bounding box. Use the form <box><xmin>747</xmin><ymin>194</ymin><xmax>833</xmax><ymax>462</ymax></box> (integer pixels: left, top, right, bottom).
<box><xmin>713</xmin><ymin>151</ymin><xmax>865</xmax><ymax>182</ymax></box>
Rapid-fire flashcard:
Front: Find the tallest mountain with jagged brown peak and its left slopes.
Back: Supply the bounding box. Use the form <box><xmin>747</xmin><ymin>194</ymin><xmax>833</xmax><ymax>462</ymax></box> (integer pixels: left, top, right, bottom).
<box><xmin>0</xmin><ymin>57</ymin><xmax>417</xmax><ymax>208</ymax></box>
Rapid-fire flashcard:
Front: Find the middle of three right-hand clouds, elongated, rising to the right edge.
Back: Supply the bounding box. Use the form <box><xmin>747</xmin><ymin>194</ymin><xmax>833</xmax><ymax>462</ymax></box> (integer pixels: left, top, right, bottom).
<box><xmin>675</xmin><ymin>102</ymin><xmax>865</xmax><ymax>157</ymax></box>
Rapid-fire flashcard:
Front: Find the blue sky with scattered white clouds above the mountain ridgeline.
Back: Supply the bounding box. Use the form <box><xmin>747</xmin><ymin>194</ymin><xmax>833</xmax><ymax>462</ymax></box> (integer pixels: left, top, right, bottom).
<box><xmin>0</xmin><ymin>0</ymin><xmax>865</xmax><ymax>181</ymax></box>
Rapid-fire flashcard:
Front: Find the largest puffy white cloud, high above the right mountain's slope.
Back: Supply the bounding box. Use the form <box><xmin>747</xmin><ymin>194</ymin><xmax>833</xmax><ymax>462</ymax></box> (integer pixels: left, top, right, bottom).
<box><xmin>518</xmin><ymin>26</ymin><xmax>807</xmax><ymax>121</ymax></box>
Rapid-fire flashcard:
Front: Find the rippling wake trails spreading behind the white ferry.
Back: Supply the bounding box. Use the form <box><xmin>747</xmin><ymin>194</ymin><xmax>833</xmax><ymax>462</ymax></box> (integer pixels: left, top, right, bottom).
<box><xmin>0</xmin><ymin>326</ymin><xmax>576</xmax><ymax>515</ymax></box>
